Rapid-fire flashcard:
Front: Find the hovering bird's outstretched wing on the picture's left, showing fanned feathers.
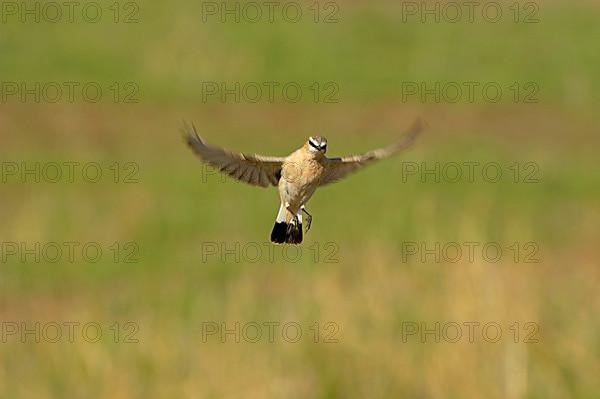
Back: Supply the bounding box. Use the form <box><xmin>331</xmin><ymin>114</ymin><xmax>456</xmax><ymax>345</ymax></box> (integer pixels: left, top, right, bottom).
<box><xmin>182</xmin><ymin>122</ymin><xmax>285</xmax><ymax>187</ymax></box>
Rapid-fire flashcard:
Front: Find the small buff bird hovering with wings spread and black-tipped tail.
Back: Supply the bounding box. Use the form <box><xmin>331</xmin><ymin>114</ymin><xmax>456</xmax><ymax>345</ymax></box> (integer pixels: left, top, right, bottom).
<box><xmin>182</xmin><ymin>119</ymin><xmax>424</xmax><ymax>244</ymax></box>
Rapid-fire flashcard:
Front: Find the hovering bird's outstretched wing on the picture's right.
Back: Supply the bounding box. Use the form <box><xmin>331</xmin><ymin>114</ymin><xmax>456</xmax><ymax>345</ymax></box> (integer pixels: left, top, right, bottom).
<box><xmin>319</xmin><ymin>119</ymin><xmax>424</xmax><ymax>186</ymax></box>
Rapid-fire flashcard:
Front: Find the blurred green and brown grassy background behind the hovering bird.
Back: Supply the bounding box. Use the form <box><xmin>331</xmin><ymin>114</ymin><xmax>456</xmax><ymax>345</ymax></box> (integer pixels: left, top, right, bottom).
<box><xmin>0</xmin><ymin>1</ymin><xmax>600</xmax><ymax>398</ymax></box>
